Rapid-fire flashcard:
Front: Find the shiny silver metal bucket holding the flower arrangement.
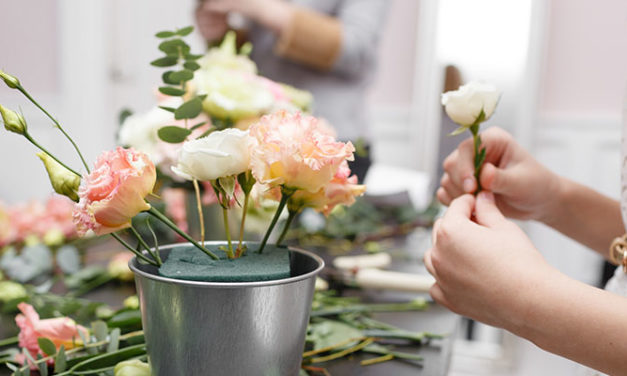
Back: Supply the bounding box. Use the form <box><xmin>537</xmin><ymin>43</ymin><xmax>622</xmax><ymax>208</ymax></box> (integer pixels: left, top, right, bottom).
<box><xmin>129</xmin><ymin>242</ymin><xmax>324</xmax><ymax>376</ymax></box>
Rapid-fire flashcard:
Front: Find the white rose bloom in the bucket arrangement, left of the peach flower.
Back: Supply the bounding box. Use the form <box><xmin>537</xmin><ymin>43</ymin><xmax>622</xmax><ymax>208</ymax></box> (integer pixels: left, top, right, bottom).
<box><xmin>172</xmin><ymin>128</ymin><xmax>250</xmax><ymax>181</ymax></box>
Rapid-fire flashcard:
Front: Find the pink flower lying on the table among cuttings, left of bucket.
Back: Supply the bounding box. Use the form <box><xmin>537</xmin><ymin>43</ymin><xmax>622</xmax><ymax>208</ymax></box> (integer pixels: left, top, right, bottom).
<box><xmin>15</xmin><ymin>302</ymin><xmax>89</xmax><ymax>369</ymax></box>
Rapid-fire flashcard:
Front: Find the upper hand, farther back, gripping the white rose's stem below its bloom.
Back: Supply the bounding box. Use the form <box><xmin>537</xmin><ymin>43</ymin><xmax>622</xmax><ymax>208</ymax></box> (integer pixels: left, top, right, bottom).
<box><xmin>437</xmin><ymin>128</ymin><xmax>561</xmax><ymax>221</ymax></box>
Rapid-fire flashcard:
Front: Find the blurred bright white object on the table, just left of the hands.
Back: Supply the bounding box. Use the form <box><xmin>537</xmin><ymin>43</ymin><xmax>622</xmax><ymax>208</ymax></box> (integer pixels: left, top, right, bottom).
<box><xmin>365</xmin><ymin>163</ymin><xmax>431</xmax><ymax>210</ymax></box>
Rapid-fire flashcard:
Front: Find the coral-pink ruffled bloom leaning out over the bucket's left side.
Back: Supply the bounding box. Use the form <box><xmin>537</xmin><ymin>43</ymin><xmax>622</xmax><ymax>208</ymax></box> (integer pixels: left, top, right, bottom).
<box><xmin>74</xmin><ymin>147</ymin><xmax>157</xmax><ymax>235</ymax></box>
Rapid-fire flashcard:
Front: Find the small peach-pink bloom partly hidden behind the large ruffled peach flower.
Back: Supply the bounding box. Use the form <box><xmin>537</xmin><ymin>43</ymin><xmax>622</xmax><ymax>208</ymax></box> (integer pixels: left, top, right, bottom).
<box><xmin>288</xmin><ymin>161</ymin><xmax>366</xmax><ymax>216</ymax></box>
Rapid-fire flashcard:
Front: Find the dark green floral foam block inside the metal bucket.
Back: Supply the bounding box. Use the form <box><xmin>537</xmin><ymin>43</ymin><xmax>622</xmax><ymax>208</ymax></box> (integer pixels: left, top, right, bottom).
<box><xmin>159</xmin><ymin>244</ymin><xmax>290</xmax><ymax>282</ymax></box>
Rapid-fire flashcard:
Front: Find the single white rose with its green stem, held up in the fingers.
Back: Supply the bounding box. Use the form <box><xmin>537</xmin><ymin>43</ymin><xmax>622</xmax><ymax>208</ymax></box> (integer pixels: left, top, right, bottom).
<box><xmin>442</xmin><ymin>82</ymin><xmax>501</xmax><ymax>193</ymax></box>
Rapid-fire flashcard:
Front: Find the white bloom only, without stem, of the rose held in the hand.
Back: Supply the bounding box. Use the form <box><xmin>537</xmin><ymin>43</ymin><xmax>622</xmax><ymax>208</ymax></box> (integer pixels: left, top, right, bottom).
<box><xmin>442</xmin><ymin>82</ymin><xmax>501</xmax><ymax>128</ymax></box>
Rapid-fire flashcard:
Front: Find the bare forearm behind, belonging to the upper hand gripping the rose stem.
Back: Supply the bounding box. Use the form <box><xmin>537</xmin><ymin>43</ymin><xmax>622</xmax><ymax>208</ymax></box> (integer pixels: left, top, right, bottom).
<box><xmin>542</xmin><ymin>178</ymin><xmax>625</xmax><ymax>257</ymax></box>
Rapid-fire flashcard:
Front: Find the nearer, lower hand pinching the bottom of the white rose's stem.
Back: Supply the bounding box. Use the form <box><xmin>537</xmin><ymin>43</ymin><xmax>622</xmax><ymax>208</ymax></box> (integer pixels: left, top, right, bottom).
<box><xmin>424</xmin><ymin>191</ymin><xmax>555</xmax><ymax>330</ymax></box>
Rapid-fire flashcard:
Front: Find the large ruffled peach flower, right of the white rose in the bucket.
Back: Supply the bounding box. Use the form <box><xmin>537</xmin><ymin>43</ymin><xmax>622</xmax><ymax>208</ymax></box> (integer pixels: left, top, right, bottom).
<box><xmin>250</xmin><ymin>111</ymin><xmax>355</xmax><ymax>192</ymax></box>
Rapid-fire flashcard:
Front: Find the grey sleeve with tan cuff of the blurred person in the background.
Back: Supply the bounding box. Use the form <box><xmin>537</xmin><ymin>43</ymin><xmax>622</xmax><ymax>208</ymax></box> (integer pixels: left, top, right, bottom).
<box><xmin>275</xmin><ymin>0</ymin><xmax>386</xmax><ymax>75</ymax></box>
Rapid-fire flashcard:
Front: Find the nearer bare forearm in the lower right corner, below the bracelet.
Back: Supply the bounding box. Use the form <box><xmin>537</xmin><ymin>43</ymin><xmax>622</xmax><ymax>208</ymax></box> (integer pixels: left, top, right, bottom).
<box><xmin>506</xmin><ymin>271</ymin><xmax>627</xmax><ymax>375</ymax></box>
